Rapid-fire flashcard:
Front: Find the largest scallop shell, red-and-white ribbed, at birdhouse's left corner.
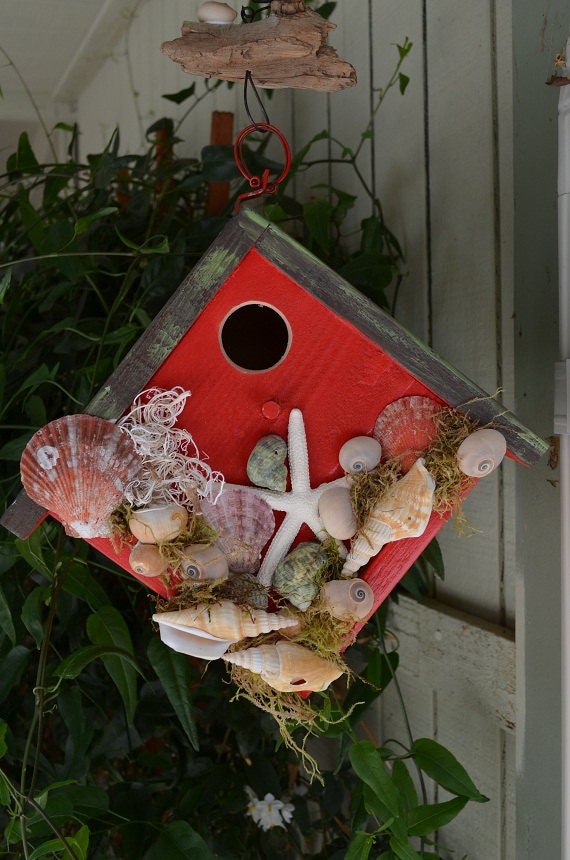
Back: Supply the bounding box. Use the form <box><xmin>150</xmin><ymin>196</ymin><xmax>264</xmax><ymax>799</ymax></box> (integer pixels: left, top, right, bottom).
<box><xmin>20</xmin><ymin>415</ymin><xmax>142</xmax><ymax>538</ymax></box>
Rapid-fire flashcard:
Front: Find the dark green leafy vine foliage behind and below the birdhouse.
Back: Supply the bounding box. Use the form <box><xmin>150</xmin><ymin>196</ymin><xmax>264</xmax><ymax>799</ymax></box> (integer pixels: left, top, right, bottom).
<box><xmin>0</xmin><ymin>40</ymin><xmax>485</xmax><ymax>860</ymax></box>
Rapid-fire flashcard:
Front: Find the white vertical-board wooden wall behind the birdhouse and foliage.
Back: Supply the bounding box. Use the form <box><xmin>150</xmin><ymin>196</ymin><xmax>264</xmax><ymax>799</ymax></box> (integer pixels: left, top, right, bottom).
<box><xmin>47</xmin><ymin>0</ymin><xmax>568</xmax><ymax>860</ymax></box>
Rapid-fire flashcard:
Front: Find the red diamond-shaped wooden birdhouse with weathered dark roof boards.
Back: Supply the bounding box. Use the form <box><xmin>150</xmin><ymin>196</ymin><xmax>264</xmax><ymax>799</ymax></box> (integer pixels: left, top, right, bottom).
<box><xmin>2</xmin><ymin>210</ymin><xmax>546</xmax><ymax>615</ymax></box>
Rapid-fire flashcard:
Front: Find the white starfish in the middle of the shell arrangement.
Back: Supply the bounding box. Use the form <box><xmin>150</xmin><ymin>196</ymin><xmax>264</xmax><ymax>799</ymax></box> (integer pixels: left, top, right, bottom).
<box><xmin>227</xmin><ymin>409</ymin><xmax>348</xmax><ymax>586</ymax></box>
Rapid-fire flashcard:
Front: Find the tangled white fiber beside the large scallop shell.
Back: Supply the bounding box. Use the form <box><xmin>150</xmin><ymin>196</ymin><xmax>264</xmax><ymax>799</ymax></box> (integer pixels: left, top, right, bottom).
<box><xmin>117</xmin><ymin>385</ymin><xmax>224</xmax><ymax>508</ymax></box>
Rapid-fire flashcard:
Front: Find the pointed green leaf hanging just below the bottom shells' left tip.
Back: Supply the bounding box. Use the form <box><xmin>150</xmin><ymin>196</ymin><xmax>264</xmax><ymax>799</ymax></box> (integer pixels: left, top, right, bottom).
<box><xmin>147</xmin><ymin>637</ymin><xmax>199</xmax><ymax>750</ymax></box>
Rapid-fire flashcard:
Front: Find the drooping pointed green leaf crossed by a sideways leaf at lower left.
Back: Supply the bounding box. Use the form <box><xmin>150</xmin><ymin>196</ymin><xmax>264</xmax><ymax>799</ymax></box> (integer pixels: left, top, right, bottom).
<box><xmin>87</xmin><ymin>606</ymin><xmax>141</xmax><ymax>723</ymax></box>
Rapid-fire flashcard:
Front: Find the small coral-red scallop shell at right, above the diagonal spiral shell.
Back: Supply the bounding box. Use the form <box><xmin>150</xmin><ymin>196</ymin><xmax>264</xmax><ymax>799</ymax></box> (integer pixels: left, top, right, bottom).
<box><xmin>374</xmin><ymin>394</ymin><xmax>441</xmax><ymax>473</ymax></box>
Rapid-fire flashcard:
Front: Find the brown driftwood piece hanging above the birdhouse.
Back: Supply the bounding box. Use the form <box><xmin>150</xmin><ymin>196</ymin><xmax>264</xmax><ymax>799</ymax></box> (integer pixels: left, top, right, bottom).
<box><xmin>161</xmin><ymin>0</ymin><xmax>356</xmax><ymax>92</ymax></box>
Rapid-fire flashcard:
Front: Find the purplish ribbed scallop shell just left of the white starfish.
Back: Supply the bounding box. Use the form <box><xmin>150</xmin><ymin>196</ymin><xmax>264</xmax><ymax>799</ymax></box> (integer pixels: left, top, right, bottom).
<box><xmin>201</xmin><ymin>487</ymin><xmax>275</xmax><ymax>573</ymax></box>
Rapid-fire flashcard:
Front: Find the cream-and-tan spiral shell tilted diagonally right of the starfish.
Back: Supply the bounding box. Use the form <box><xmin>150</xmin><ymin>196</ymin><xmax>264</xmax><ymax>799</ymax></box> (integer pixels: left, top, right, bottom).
<box><xmin>342</xmin><ymin>459</ymin><xmax>435</xmax><ymax>576</ymax></box>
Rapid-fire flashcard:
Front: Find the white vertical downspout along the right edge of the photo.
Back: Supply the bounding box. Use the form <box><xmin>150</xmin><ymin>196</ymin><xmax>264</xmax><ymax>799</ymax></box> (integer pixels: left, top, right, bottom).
<box><xmin>554</xmin><ymin>38</ymin><xmax>570</xmax><ymax>860</ymax></box>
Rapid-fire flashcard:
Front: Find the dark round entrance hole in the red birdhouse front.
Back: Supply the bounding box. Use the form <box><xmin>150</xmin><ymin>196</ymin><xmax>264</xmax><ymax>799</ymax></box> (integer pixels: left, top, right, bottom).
<box><xmin>220</xmin><ymin>304</ymin><xmax>291</xmax><ymax>371</ymax></box>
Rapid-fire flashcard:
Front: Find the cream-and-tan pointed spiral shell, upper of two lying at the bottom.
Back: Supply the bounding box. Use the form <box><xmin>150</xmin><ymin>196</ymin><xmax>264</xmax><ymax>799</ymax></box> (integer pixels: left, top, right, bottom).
<box><xmin>153</xmin><ymin>600</ymin><xmax>297</xmax><ymax>642</ymax></box>
